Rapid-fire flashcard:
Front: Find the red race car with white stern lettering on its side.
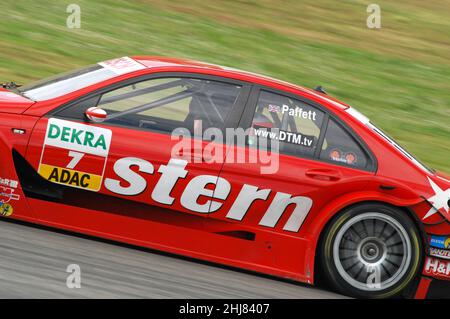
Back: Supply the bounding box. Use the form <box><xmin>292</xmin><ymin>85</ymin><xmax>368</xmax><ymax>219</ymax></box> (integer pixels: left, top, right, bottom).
<box><xmin>0</xmin><ymin>56</ymin><xmax>450</xmax><ymax>298</ymax></box>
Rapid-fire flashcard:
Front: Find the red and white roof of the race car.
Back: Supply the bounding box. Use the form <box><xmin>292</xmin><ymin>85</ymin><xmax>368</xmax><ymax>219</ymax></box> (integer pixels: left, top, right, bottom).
<box><xmin>131</xmin><ymin>56</ymin><xmax>350</xmax><ymax>110</ymax></box>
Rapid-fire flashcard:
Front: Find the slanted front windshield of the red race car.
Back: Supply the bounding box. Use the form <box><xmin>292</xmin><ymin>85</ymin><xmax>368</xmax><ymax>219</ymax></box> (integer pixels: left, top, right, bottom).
<box><xmin>19</xmin><ymin>64</ymin><xmax>117</xmax><ymax>101</ymax></box>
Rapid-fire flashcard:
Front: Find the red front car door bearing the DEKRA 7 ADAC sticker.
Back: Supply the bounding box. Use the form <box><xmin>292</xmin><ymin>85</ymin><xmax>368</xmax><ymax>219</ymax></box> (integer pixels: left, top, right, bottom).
<box><xmin>23</xmin><ymin>74</ymin><xmax>249</xmax><ymax>245</ymax></box>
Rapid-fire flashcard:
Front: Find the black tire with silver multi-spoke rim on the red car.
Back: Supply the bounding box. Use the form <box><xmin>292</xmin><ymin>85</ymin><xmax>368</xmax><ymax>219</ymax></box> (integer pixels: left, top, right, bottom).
<box><xmin>319</xmin><ymin>203</ymin><xmax>423</xmax><ymax>298</ymax></box>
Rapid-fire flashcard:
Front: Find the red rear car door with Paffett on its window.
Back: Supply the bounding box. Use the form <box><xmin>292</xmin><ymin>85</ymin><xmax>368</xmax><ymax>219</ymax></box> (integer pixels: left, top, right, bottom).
<box><xmin>210</xmin><ymin>88</ymin><xmax>374</xmax><ymax>273</ymax></box>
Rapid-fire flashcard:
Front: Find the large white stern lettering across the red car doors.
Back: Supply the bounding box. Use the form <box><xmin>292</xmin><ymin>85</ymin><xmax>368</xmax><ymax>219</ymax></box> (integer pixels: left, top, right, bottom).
<box><xmin>104</xmin><ymin>157</ymin><xmax>313</xmax><ymax>232</ymax></box>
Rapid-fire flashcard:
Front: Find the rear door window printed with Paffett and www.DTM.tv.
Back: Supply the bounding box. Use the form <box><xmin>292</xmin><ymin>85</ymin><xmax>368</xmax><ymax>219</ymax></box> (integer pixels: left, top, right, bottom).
<box><xmin>249</xmin><ymin>91</ymin><xmax>324</xmax><ymax>157</ymax></box>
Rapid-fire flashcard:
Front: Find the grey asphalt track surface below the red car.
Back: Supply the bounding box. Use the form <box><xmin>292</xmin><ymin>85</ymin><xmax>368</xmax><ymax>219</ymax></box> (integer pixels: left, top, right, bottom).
<box><xmin>0</xmin><ymin>220</ymin><xmax>342</xmax><ymax>299</ymax></box>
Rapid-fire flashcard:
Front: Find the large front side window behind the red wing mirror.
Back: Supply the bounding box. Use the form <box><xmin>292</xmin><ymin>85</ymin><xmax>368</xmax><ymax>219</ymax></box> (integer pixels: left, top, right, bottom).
<box><xmin>56</xmin><ymin>78</ymin><xmax>241</xmax><ymax>133</ymax></box>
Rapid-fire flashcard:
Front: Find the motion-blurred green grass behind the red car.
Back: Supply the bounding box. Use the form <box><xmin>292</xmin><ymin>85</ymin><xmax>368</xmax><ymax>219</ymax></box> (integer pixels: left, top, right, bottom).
<box><xmin>0</xmin><ymin>0</ymin><xmax>450</xmax><ymax>173</ymax></box>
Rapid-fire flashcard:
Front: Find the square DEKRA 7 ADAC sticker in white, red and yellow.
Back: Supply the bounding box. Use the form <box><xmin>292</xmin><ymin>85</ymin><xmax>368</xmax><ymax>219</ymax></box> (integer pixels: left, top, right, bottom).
<box><xmin>38</xmin><ymin>118</ymin><xmax>112</xmax><ymax>192</ymax></box>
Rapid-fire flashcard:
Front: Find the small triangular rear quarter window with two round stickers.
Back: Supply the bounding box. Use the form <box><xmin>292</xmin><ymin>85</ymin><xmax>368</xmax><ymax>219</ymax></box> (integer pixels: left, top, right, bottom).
<box><xmin>320</xmin><ymin>119</ymin><xmax>368</xmax><ymax>168</ymax></box>
